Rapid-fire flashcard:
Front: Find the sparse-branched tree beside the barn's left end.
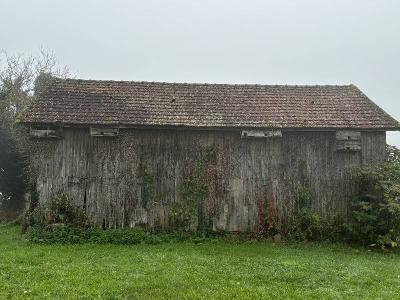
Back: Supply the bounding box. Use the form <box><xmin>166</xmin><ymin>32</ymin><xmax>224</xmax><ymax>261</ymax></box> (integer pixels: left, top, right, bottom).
<box><xmin>0</xmin><ymin>50</ymin><xmax>69</xmax><ymax>217</ymax></box>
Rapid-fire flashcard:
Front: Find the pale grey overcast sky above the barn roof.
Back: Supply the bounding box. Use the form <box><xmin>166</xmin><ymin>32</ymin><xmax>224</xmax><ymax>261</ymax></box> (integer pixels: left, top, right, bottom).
<box><xmin>0</xmin><ymin>0</ymin><xmax>400</xmax><ymax>146</ymax></box>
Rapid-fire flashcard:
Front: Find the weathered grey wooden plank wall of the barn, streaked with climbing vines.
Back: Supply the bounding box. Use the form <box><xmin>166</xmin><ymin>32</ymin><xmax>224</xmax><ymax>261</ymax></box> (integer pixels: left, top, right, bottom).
<box><xmin>32</xmin><ymin>128</ymin><xmax>386</xmax><ymax>231</ymax></box>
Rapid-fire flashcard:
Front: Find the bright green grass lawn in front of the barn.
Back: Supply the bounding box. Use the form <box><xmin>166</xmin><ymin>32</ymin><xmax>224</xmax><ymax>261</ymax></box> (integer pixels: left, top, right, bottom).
<box><xmin>0</xmin><ymin>225</ymin><xmax>400</xmax><ymax>299</ymax></box>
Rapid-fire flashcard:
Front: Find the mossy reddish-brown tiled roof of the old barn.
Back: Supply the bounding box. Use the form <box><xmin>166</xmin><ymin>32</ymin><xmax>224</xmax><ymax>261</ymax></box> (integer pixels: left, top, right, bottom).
<box><xmin>23</xmin><ymin>79</ymin><xmax>399</xmax><ymax>130</ymax></box>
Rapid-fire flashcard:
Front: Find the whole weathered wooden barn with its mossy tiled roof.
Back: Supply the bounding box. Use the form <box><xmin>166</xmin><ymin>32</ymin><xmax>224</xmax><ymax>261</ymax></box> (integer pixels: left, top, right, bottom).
<box><xmin>23</xmin><ymin>79</ymin><xmax>399</xmax><ymax>231</ymax></box>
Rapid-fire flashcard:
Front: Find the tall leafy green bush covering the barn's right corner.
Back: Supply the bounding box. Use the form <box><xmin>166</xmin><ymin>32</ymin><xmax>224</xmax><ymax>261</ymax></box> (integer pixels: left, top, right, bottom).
<box><xmin>346</xmin><ymin>147</ymin><xmax>400</xmax><ymax>249</ymax></box>
